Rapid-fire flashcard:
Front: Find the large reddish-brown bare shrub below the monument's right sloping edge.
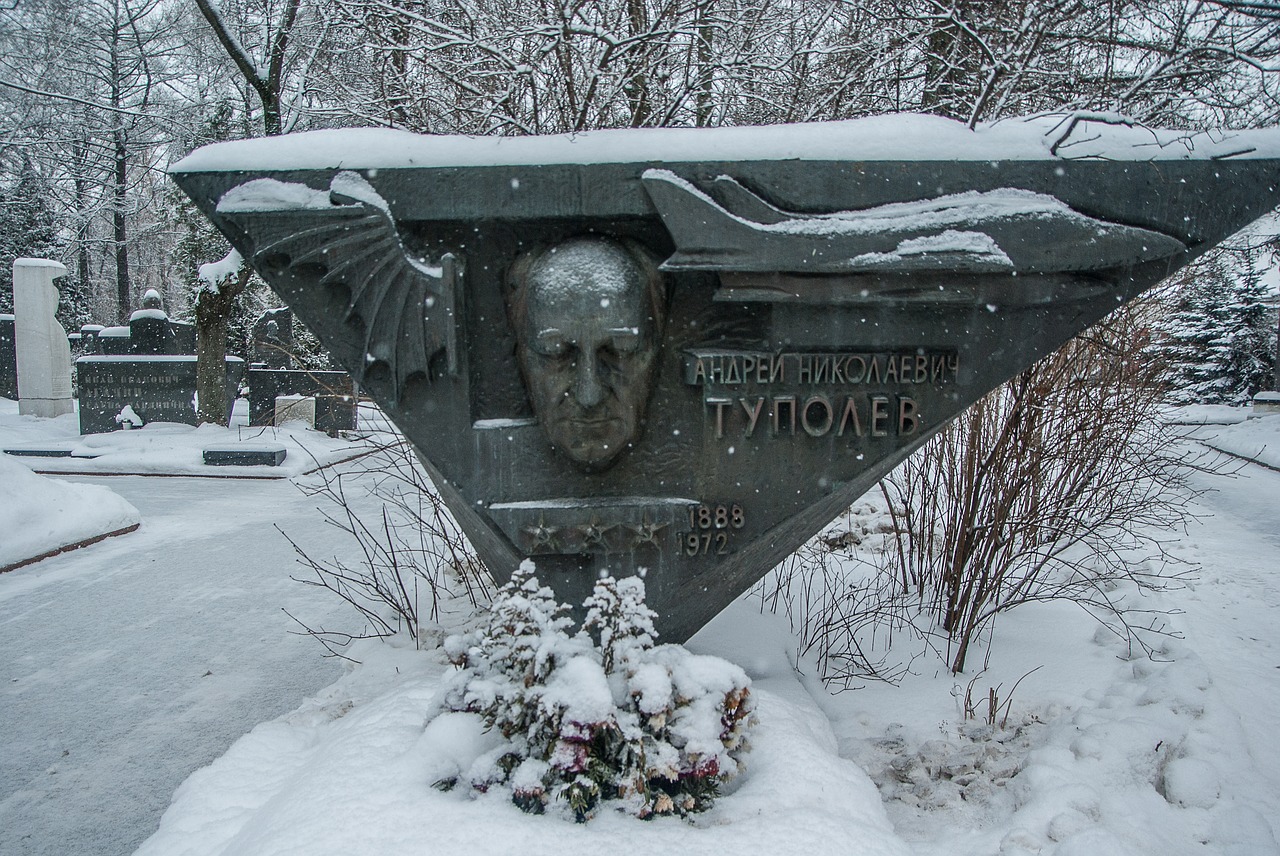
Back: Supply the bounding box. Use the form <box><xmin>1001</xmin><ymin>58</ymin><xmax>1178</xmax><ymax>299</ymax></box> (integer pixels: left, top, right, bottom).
<box><xmin>881</xmin><ymin>305</ymin><xmax>1194</xmax><ymax>672</ymax></box>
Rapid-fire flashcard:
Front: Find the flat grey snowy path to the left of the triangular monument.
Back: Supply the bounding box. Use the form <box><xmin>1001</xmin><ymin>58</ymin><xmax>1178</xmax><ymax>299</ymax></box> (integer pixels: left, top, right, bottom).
<box><xmin>0</xmin><ymin>477</ymin><xmax>353</xmax><ymax>856</ymax></box>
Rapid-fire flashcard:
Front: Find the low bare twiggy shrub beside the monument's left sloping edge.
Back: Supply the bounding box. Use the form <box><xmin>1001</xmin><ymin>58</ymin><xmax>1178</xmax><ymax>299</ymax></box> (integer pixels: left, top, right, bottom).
<box><xmin>284</xmin><ymin>431</ymin><xmax>493</xmax><ymax>656</ymax></box>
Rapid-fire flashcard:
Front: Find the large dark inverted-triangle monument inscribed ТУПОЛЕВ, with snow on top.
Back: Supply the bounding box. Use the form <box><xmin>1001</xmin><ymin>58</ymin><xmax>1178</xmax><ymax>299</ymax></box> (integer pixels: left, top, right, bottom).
<box><xmin>172</xmin><ymin>116</ymin><xmax>1280</xmax><ymax>641</ymax></box>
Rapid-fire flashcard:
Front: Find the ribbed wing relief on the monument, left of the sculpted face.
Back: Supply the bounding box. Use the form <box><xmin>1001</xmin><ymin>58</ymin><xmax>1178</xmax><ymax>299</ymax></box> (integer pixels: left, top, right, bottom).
<box><xmin>218</xmin><ymin>171</ymin><xmax>462</xmax><ymax>404</ymax></box>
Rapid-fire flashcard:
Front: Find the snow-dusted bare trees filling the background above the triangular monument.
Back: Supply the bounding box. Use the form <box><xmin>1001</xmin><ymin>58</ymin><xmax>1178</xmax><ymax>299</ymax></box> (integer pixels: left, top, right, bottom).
<box><xmin>0</xmin><ymin>0</ymin><xmax>1280</xmax><ymax>321</ymax></box>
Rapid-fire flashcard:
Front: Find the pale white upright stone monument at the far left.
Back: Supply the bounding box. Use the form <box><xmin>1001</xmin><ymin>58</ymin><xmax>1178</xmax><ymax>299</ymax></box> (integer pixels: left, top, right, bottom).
<box><xmin>13</xmin><ymin>258</ymin><xmax>76</xmax><ymax>418</ymax></box>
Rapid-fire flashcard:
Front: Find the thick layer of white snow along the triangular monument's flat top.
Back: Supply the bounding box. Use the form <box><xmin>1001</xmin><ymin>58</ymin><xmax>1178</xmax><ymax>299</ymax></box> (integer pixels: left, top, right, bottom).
<box><xmin>170</xmin><ymin>114</ymin><xmax>1280</xmax><ymax>173</ymax></box>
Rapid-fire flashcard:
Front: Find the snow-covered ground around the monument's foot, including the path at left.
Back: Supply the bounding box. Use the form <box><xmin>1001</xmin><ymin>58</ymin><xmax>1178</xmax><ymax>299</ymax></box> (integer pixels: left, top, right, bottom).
<box><xmin>0</xmin><ymin>401</ymin><xmax>1280</xmax><ymax>856</ymax></box>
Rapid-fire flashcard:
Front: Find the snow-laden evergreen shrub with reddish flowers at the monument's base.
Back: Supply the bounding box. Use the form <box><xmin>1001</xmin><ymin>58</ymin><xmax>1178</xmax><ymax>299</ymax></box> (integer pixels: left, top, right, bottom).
<box><xmin>436</xmin><ymin>562</ymin><xmax>753</xmax><ymax>821</ymax></box>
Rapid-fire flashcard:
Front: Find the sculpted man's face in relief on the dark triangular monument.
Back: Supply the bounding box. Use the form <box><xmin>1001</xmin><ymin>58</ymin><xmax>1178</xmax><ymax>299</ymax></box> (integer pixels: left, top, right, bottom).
<box><xmin>507</xmin><ymin>237</ymin><xmax>666</xmax><ymax>471</ymax></box>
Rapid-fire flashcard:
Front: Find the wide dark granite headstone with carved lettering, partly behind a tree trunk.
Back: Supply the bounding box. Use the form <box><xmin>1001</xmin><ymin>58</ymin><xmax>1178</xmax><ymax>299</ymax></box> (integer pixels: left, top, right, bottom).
<box><xmin>76</xmin><ymin>356</ymin><xmax>244</xmax><ymax>434</ymax></box>
